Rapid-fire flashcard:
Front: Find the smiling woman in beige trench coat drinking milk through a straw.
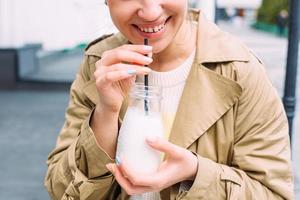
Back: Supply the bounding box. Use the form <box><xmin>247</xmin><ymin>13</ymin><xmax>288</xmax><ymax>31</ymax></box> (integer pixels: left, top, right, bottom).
<box><xmin>45</xmin><ymin>0</ymin><xmax>293</xmax><ymax>200</ymax></box>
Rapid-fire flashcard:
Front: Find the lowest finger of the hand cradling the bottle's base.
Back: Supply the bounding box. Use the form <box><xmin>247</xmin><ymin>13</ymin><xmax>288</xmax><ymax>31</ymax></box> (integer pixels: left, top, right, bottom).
<box><xmin>108</xmin><ymin>164</ymin><xmax>151</xmax><ymax>195</ymax></box>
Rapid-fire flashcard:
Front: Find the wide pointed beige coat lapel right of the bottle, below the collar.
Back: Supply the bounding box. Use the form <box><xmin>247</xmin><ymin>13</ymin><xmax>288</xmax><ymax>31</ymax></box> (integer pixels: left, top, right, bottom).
<box><xmin>169</xmin><ymin>63</ymin><xmax>242</xmax><ymax>148</ymax></box>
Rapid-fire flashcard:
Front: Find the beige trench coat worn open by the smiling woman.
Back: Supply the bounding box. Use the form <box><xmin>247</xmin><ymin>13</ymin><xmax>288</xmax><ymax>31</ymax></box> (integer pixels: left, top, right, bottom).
<box><xmin>45</xmin><ymin>11</ymin><xmax>293</xmax><ymax>200</ymax></box>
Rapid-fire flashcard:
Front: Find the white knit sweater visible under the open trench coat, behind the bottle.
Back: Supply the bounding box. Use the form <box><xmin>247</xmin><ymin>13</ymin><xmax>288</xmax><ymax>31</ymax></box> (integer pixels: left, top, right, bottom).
<box><xmin>130</xmin><ymin>50</ymin><xmax>195</xmax><ymax>200</ymax></box>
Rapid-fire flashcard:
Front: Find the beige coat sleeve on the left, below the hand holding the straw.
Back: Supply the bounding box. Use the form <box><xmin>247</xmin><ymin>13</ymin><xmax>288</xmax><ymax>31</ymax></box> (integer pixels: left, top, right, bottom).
<box><xmin>45</xmin><ymin>57</ymin><xmax>116</xmax><ymax>200</ymax></box>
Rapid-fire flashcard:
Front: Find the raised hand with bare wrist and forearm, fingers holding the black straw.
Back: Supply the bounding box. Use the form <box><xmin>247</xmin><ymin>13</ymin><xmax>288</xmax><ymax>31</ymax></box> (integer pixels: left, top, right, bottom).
<box><xmin>90</xmin><ymin>45</ymin><xmax>152</xmax><ymax>158</ymax></box>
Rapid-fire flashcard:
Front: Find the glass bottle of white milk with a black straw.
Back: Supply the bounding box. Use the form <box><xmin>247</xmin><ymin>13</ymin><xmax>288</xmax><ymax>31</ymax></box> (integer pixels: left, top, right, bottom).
<box><xmin>116</xmin><ymin>83</ymin><xmax>163</xmax><ymax>174</ymax></box>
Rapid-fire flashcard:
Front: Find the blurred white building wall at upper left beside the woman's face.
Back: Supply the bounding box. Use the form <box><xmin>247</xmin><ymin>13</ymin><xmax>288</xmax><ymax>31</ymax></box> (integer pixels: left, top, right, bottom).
<box><xmin>0</xmin><ymin>0</ymin><xmax>113</xmax><ymax>50</ymax></box>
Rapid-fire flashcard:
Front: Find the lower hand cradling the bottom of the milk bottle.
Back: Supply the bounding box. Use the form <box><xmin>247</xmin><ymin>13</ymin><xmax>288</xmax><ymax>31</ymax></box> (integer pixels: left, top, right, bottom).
<box><xmin>106</xmin><ymin>138</ymin><xmax>198</xmax><ymax>195</ymax></box>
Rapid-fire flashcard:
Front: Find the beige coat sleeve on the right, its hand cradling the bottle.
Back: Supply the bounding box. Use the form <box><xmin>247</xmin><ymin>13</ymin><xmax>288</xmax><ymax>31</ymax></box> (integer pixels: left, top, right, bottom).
<box><xmin>178</xmin><ymin>56</ymin><xmax>294</xmax><ymax>200</ymax></box>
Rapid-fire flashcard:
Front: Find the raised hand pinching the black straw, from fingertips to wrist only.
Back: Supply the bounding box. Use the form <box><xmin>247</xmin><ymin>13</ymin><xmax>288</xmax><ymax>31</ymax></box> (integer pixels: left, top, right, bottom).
<box><xmin>94</xmin><ymin>45</ymin><xmax>152</xmax><ymax>113</ymax></box>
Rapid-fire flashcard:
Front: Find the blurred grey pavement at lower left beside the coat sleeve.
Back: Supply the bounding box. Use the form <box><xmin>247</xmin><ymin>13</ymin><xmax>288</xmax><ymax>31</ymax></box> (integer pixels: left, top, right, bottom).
<box><xmin>0</xmin><ymin>90</ymin><xmax>68</xmax><ymax>200</ymax></box>
